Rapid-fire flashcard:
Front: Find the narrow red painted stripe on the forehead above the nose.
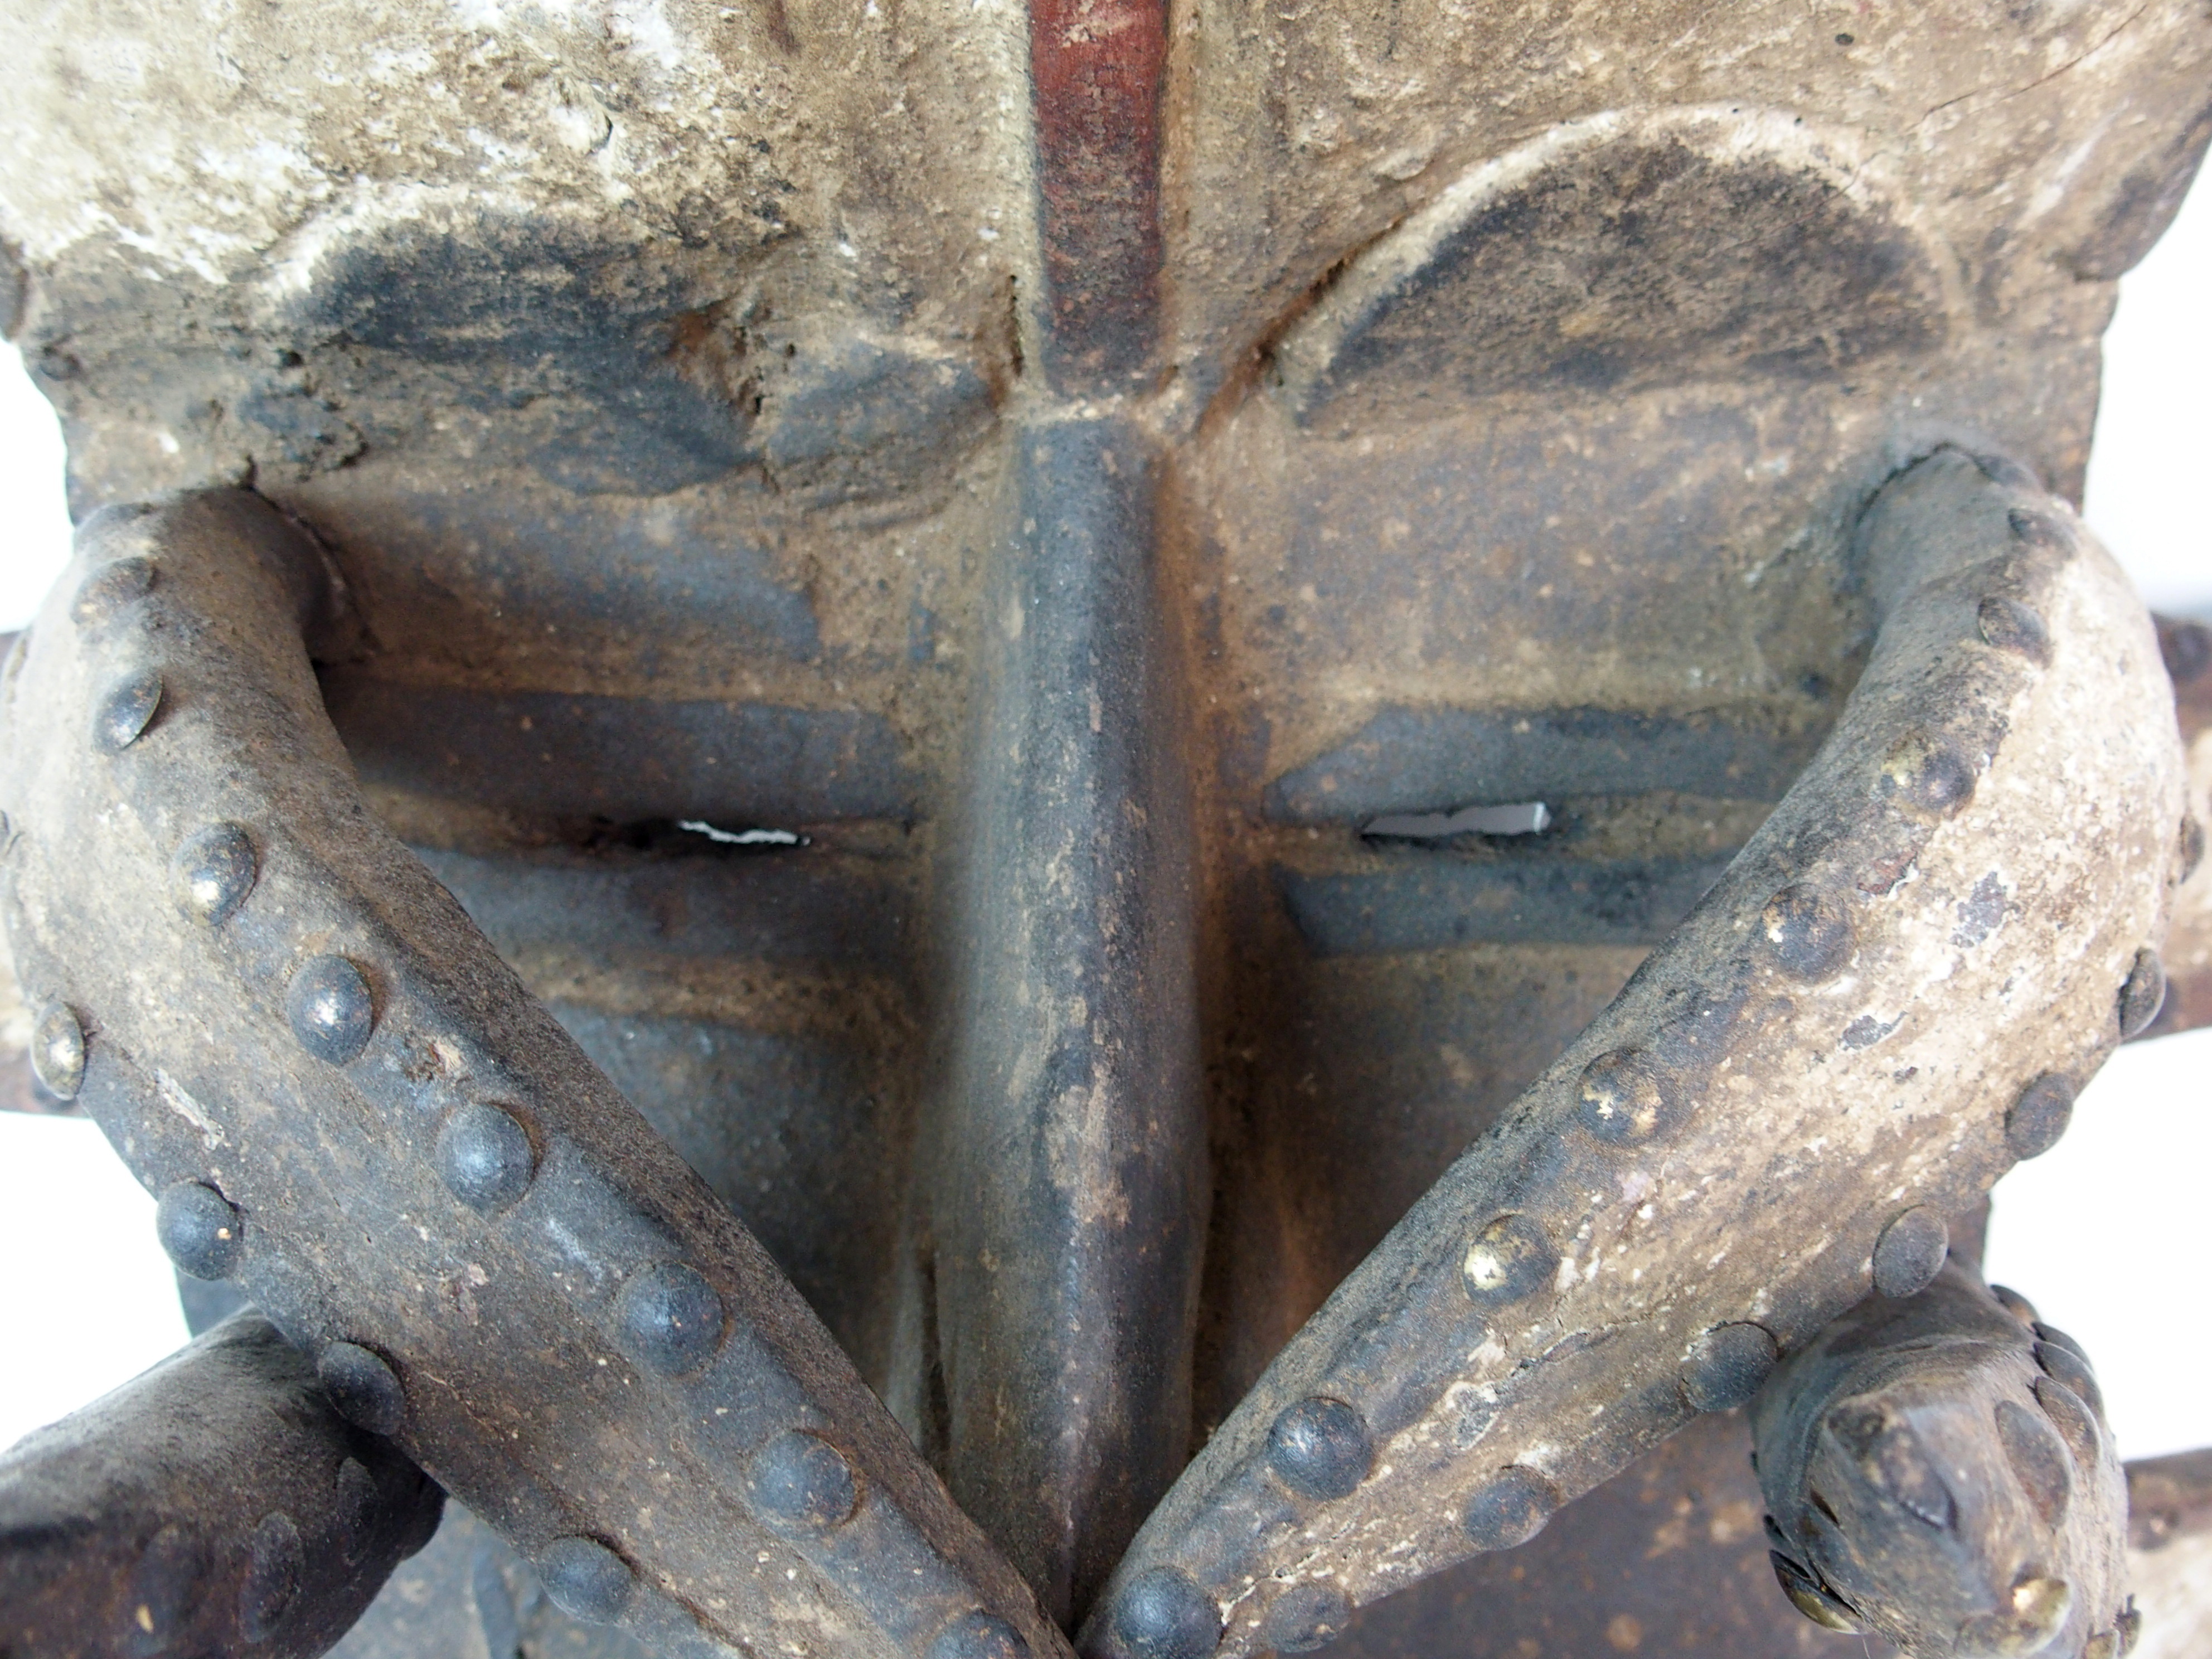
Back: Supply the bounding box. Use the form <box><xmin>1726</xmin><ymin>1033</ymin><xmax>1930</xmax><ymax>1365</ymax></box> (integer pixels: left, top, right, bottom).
<box><xmin>1029</xmin><ymin>0</ymin><xmax>1168</xmax><ymax>389</ymax></box>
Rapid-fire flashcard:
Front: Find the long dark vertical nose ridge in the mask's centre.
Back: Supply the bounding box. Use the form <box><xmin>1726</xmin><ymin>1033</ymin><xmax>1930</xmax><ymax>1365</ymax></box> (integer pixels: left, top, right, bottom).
<box><xmin>905</xmin><ymin>420</ymin><xmax>1208</xmax><ymax>1624</ymax></box>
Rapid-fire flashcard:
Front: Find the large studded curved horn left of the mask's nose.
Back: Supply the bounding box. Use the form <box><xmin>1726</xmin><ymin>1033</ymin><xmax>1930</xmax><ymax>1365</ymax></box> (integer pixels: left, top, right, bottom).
<box><xmin>0</xmin><ymin>493</ymin><xmax>1064</xmax><ymax>1659</ymax></box>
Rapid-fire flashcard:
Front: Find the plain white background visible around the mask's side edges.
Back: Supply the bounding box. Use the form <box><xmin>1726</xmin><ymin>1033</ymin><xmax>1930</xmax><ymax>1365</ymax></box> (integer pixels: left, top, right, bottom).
<box><xmin>0</xmin><ymin>183</ymin><xmax>2212</xmax><ymax>1458</ymax></box>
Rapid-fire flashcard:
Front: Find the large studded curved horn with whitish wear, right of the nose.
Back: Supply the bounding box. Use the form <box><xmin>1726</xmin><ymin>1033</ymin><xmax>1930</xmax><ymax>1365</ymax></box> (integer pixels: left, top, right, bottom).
<box><xmin>1079</xmin><ymin>451</ymin><xmax>2183</xmax><ymax>1659</ymax></box>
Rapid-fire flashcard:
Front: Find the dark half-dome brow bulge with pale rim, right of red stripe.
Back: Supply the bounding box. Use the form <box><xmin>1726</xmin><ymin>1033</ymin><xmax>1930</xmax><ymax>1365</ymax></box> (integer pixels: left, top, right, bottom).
<box><xmin>1272</xmin><ymin>113</ymin><xmax>1947</xmax><ymax>434</ymax></box>
